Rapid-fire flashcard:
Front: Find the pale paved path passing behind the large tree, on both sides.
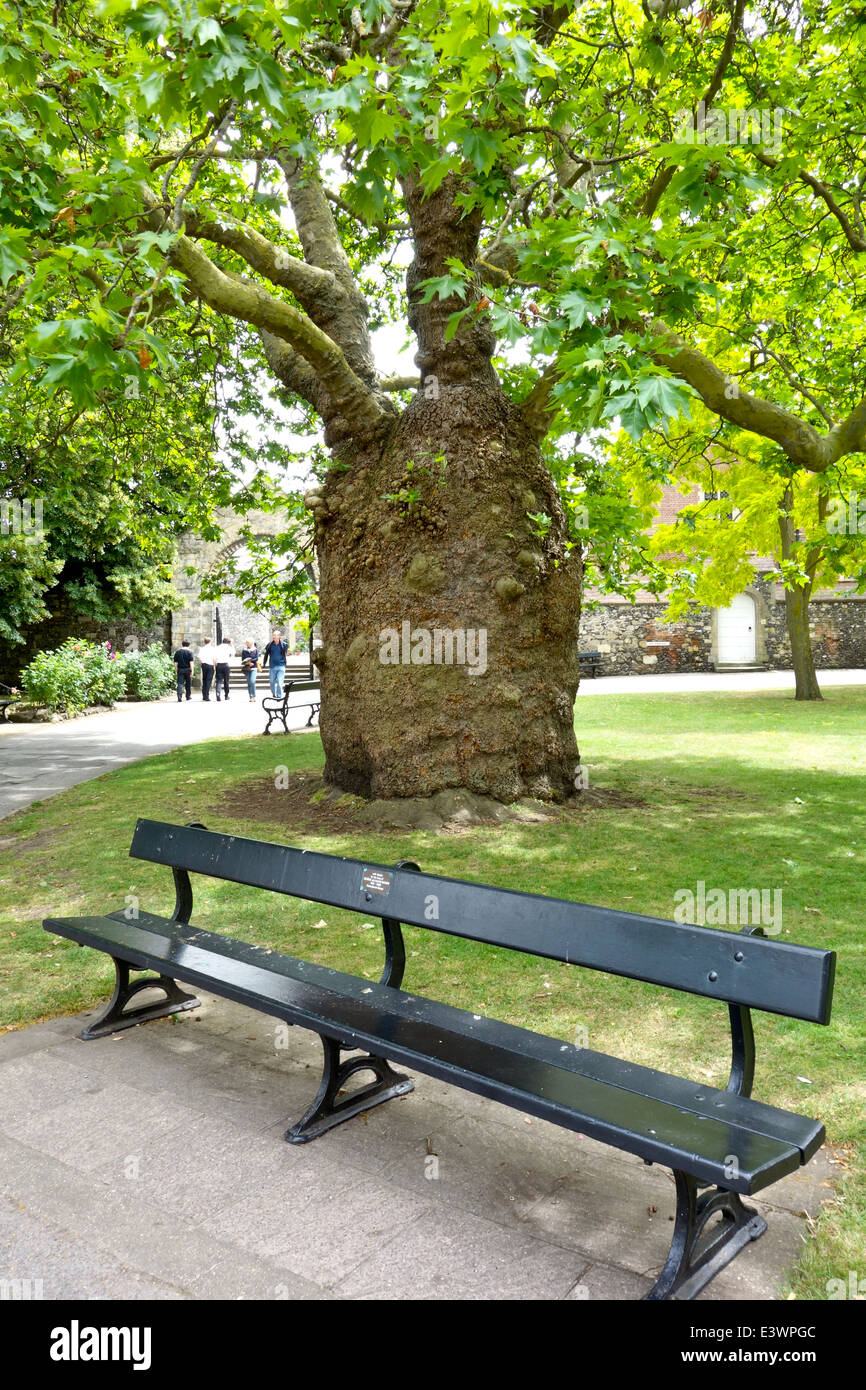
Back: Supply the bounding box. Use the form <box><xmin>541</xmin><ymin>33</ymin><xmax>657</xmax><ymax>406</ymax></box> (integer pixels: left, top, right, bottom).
<box><xmin>0</xmin><ymin>670</ymin><xmax>866</xmax><ymax>820</ymax></box>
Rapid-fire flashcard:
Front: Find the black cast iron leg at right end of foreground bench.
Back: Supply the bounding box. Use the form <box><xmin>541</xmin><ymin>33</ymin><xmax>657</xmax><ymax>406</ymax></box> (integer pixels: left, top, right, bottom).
<box><xmin>646</xmin><ymin>1170</ymin><xmax>767</xmax><ymax>1301</ymax></box>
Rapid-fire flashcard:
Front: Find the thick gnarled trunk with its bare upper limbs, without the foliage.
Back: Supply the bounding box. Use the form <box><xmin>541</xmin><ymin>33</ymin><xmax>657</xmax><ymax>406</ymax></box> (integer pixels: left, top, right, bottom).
<box><xmin>162</xmin><ymin>158</ymin><xmax>581</xmax><ymax>802</ymax></box>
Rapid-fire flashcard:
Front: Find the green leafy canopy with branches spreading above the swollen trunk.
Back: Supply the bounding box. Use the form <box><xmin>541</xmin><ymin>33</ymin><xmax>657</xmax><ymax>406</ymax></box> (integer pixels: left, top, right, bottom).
<box><xmin>0</xmin><ymin>0</ymin><xmax>866</xmax><ymax>473</ymax></box>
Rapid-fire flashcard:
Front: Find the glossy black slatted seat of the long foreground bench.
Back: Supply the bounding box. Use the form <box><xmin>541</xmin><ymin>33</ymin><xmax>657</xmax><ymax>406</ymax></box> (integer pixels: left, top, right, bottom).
<box><xmin>44</xmin><ymin>913</ymin><xmax>823</xmax><ymax>1193</ymax></box>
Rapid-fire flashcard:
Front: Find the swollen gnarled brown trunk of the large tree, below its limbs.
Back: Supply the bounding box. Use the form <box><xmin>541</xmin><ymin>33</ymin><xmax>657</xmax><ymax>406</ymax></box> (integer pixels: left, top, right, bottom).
<box><xmin>314</xmin><ymin>386</ymin><xmax>581</xmax><ymax>802</ymax></box>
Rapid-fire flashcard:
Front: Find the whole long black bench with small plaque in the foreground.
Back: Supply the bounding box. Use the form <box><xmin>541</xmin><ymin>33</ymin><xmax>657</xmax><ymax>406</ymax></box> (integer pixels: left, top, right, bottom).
<box><xmin>44</xmin><ymin>820</ymin><xmax>835</xmax><ymax>1298</ymax></box>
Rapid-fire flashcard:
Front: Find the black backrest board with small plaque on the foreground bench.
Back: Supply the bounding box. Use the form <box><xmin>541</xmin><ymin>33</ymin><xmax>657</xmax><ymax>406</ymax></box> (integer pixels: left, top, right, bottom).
<box><xmin>129</xmin><ymin>820</ymin><xmax>835</xmax><ymax>1023</ymax></box>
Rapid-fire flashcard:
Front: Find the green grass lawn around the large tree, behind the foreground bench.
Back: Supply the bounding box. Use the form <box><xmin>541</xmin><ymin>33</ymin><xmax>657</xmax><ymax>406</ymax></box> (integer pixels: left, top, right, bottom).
<box><xmin>0</xmin><ymin>687</ymin><xmax>866</xmax><ymax>1298</ymax></box>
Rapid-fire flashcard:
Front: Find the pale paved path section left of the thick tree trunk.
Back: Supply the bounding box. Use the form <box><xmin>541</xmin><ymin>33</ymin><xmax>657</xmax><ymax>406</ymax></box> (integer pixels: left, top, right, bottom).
<box><xmin>0</xmin><ymin>685</ymin><xmax>316</xmax><ymax>820</ymax></box>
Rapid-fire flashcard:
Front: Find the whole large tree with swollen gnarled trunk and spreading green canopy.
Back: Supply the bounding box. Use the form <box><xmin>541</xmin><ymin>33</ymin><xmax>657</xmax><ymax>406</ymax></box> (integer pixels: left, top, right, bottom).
<box><xmin>6</xmin><ymin>0</ymin><xmax>866</xmax><ymax>801</ymax></box>
